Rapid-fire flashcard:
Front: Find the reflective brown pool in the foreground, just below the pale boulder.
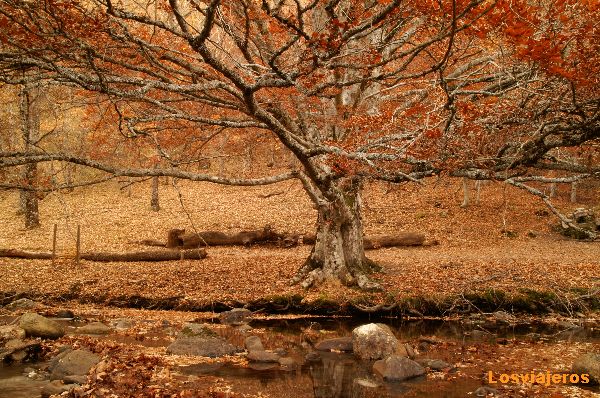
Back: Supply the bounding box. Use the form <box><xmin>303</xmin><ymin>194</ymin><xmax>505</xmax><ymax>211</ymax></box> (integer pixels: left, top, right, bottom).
<box><xmin>180</xmin><ymin>352</ymin><xmax>481</xmax><ymax>398</ymax></box>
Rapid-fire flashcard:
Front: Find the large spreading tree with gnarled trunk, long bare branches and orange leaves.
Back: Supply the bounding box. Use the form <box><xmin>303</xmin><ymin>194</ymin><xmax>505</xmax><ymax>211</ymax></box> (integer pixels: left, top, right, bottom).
<box><xmin>0</xmin><ymin>0</ymin><xmax>600</xmax><ymax>288</ymax></box>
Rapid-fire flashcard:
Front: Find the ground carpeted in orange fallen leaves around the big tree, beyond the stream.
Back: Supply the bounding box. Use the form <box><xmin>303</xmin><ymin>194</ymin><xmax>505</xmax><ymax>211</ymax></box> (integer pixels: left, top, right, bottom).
<box><xmin>0</xmin><ymin>179</ymin><xmax>600</xmax><ymax>314</ymax></box>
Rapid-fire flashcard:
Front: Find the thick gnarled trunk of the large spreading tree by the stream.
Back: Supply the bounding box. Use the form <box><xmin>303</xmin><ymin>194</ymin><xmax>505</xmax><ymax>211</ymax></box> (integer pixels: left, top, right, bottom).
<box><xmin>292</xmin><ymin>180</ymin><xmax>380</xmax><ymax>290</ymax></box>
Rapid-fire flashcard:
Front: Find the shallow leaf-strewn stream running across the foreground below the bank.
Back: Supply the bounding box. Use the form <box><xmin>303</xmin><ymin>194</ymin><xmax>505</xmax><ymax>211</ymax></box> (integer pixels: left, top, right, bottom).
<box><xmin>0</xmin><ymin>317</ymin><xmax>600</xmax><ymax>398</ymax></box>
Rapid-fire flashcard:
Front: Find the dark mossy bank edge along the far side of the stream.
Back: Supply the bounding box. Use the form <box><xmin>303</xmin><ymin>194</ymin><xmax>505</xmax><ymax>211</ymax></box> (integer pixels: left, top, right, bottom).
<box><xmin>0</xmin><ymin>288</ymin><xmax>600</xmax><ymax>317</ymax></box>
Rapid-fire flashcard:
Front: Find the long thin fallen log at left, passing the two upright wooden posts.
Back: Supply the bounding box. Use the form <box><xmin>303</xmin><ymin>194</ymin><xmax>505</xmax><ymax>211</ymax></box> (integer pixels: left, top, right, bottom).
<box><xmin>0</xmin><ymin>249</ymin><xmax>207</xmax><ymax>262</ymax></box>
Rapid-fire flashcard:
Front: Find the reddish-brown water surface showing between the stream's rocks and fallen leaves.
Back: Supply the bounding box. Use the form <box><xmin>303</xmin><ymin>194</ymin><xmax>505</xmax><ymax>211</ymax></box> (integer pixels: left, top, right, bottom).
<box><xmin>0</xmin><ymin>317</ymin><xmax>600</xmax><ymax>398</ymax></box>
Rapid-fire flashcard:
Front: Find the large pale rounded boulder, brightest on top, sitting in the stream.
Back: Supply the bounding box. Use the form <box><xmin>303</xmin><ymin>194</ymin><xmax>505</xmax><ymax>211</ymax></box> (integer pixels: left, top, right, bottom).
<box><xmin>352</xmin><ymin>323</ymin><xmax>400</xmax><ymax>359</ymax></box>
